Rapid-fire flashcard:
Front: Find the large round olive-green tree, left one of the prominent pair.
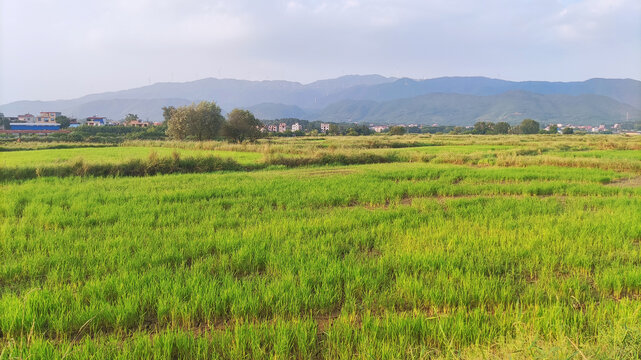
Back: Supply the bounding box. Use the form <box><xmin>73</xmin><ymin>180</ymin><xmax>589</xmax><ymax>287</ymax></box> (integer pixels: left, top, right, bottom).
<box><xmin>167</xmin><ymin>101</ymin><xmax>225</xmax><ymax>141</ymax></box>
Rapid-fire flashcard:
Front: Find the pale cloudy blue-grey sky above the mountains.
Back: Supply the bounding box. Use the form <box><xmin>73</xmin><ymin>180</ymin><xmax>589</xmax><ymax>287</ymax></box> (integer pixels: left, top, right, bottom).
<box><xmin>0</xmin><ymin>0</ymin><xmax>641</xmax><ymax>104</ymax></box>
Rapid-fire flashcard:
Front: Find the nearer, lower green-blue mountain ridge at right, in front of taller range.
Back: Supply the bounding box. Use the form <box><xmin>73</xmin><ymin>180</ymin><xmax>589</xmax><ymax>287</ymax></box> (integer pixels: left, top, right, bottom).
<box><xmin>313</xmin><ymin>91</ymin><xmax>641</xmax><ymax>125</ymax></box>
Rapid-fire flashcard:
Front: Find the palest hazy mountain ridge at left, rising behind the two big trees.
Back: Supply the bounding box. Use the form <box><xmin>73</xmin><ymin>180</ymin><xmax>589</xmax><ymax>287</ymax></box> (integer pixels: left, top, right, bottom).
<box><xmin>0</xmin><ymin>75</ymin><xmax>396</xmax><ymax>120</ymax></box>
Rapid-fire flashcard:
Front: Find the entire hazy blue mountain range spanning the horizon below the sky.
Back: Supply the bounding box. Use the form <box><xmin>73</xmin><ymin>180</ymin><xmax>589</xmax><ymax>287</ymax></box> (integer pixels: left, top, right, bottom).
<box><xmin>0</xmin><ymin>75</ymin><xmax>641</xmax><ymax>125</ymax></box>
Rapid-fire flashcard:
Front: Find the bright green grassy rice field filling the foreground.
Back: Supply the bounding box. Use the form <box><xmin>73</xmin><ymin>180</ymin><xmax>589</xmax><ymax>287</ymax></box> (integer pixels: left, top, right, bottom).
<box><xmin>0</xmin><ymin>135</ymin><xmax>641</xmax><ymax>359</ymax></box>
